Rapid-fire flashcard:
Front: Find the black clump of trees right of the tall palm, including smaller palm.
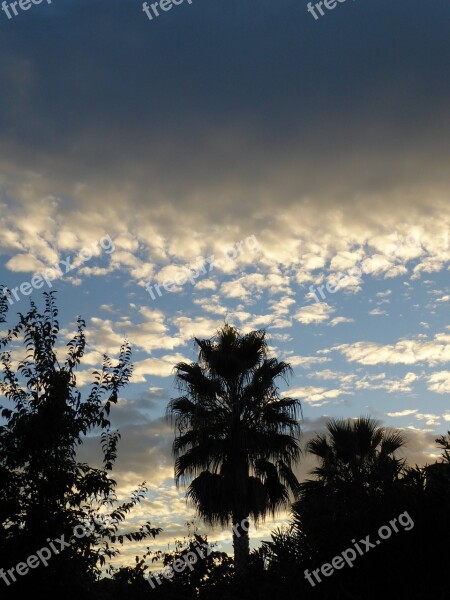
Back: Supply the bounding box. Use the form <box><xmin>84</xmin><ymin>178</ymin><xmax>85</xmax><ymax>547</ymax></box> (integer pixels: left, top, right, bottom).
<box><xmin>262</xmin><ymin>418</ymin><xmax>450</xmax><ymax>600</ymax></box>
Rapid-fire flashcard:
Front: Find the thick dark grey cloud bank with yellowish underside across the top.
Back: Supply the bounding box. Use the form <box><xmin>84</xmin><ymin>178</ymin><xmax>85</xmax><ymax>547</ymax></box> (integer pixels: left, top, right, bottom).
<box><xmin>0</xmin><ymin>0</ymin><xmax>450</xmax><ymax>255</ymax></box>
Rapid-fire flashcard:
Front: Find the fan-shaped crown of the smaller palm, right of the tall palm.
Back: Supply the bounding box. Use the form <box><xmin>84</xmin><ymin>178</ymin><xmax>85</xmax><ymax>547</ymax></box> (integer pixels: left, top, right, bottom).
<box><xmin>307</xmin><ymin>417</ymin><xmax>405</xmax><ymax>486</ymax></box>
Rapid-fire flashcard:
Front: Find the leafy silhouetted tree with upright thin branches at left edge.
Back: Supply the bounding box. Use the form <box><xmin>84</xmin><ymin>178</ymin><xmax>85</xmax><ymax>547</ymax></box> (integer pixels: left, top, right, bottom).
<box><xmin>0</xmin><ymin>290</ymin><xmax>160</xmax><ymax>598</ymax></box>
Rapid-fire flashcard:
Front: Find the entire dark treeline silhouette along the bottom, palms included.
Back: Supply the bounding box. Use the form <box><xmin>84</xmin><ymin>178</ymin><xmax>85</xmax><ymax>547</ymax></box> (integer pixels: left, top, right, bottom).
<box><xmin>0</xmin><ymin>289</ymin><xmax>450</xmax><ymax>600</ymax></box>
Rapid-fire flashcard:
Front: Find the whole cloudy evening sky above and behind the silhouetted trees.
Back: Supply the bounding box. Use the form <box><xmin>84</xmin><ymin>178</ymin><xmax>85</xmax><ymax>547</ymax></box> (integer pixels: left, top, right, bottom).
<box><xmin>0</xmin><ymin>0</ymin><xmax>450</xmax><ymax>562</ymax></box>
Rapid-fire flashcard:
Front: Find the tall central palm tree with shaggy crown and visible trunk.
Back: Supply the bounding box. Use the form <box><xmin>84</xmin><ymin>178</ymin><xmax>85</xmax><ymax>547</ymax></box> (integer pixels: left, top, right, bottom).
<box><xmin>167</xmin><ymin>325</ymin><xmax>301</xmax><ymax>577</ymax></box>
